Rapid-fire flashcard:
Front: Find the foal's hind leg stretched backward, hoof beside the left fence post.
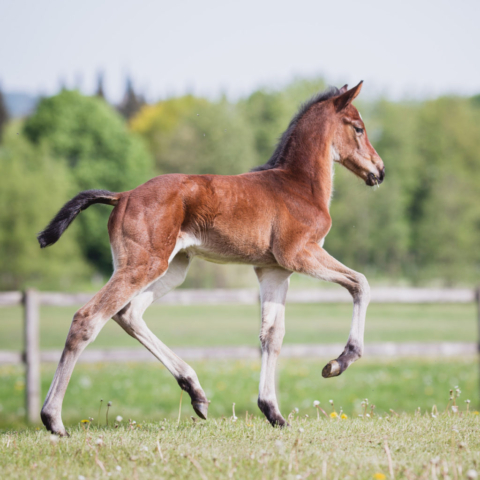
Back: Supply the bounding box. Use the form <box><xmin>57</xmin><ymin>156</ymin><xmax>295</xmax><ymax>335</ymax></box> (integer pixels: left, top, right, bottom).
<box><xmin>41</xmin><ymin>270</ymin><xmax>156</xmax><ymax>436</ymax></box>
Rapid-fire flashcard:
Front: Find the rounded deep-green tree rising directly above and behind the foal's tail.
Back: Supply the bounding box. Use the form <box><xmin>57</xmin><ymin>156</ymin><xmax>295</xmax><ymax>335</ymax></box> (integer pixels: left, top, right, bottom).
<box><xmin>24</xmin><ymin>91</ymin><xmax>152</xmax><ymax>274</ymax></box>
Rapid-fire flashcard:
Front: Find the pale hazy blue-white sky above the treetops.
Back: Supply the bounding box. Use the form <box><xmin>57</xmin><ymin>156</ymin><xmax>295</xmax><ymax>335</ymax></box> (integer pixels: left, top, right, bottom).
<box><xmin>0</xmin><ymin>0</ymin><xmax>480</xmax><ymax>101</ymax></box>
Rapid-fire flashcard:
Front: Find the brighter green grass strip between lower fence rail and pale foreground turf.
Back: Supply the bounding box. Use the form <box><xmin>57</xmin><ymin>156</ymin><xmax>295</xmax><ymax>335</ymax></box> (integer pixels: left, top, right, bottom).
<box><xmin>0</xmin><ymin>358</ymin><xmax>478</xmax><ymax>428</ymax></box>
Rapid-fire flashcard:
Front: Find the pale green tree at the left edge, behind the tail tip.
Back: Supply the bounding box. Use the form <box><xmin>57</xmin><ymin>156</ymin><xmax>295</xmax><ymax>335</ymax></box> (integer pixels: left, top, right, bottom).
<box><xmin>0</xmin><ymin>125</ymin><xmax>91</xmax><ymax>290</ymax></box>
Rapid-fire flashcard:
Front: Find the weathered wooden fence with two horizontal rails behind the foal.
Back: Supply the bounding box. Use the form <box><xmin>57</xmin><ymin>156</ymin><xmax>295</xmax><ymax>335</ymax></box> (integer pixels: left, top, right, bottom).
<box><xmin>0</xmin><ymin>288</ymin><xmax>480</xmax><ymax>423</ymax></box>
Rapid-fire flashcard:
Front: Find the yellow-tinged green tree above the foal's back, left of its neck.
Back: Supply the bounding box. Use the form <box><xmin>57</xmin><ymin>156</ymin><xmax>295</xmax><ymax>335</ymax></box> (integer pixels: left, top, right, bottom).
<box><xmin>131</xmin><ymin>95</ymin><xmax>257</xmax><ymax>175</ymax></box>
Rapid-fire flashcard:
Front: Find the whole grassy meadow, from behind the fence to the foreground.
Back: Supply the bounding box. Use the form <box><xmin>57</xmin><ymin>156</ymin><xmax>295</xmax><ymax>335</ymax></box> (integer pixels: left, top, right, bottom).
<box><xmin>0</xmin><ymin>304</ymin><xmax>480</xmax><ymax>480</ymax></box>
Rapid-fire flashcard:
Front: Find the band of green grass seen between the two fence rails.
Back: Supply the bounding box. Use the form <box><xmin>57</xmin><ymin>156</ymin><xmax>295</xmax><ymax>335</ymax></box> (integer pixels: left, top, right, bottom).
<box><xmin>0</xmin><ymin>304</ymin><xmax>477</xmax><ymax>350</ymax></box>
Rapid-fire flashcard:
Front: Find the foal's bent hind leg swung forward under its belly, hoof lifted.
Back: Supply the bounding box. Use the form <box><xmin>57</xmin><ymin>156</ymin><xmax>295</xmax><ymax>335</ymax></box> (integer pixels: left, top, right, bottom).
<box><xmin>113</xmin><ymin>252</ymin><xmax>210</xmax><ymax>419</ymax></box>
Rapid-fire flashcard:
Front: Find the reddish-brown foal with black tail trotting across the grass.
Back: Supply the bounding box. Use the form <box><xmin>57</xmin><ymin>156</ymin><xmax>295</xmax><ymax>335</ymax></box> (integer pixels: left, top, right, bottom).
<box><xmin>38</xmin><ymin>82</ymin><xmax>385</xmax><ymax>435</ymax></box>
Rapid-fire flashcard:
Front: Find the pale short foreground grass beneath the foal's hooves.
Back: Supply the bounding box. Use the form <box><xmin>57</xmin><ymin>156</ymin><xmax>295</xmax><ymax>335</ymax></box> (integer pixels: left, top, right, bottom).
<box><xmin>0</xmin><ymin>412</ymin><xmax>480</xmax><ymax>480</ymax></box>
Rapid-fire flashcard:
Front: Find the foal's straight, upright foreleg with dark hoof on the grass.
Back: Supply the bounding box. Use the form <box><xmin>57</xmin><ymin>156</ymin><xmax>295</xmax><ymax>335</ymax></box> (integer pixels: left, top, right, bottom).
<box><xmin>255</xmin><ymin>267</ymin><xmax>292</xmax><ymax>426</ymax></box>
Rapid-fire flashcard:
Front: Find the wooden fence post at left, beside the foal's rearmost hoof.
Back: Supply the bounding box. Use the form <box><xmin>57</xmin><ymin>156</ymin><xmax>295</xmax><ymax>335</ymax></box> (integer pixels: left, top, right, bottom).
<box><xmin>23</xmin><ymin>290</ymin><xmax>40</xmax><ymax>423</ymax></box>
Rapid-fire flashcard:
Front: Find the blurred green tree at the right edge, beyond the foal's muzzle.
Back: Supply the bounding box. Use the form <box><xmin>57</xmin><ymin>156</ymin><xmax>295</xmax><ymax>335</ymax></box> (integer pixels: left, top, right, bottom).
<box><xmin>410</xmin><ymin>97</ymin><xmax>480</xmax><ymax>284</ymax></box>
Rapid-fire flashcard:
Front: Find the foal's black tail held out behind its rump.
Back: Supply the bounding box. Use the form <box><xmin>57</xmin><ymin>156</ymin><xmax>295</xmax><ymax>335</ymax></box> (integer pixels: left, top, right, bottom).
<box><xmin>37</xmin><ymin>190</ymin><xmax>119</xmax><ymax>248</ymax></box>
